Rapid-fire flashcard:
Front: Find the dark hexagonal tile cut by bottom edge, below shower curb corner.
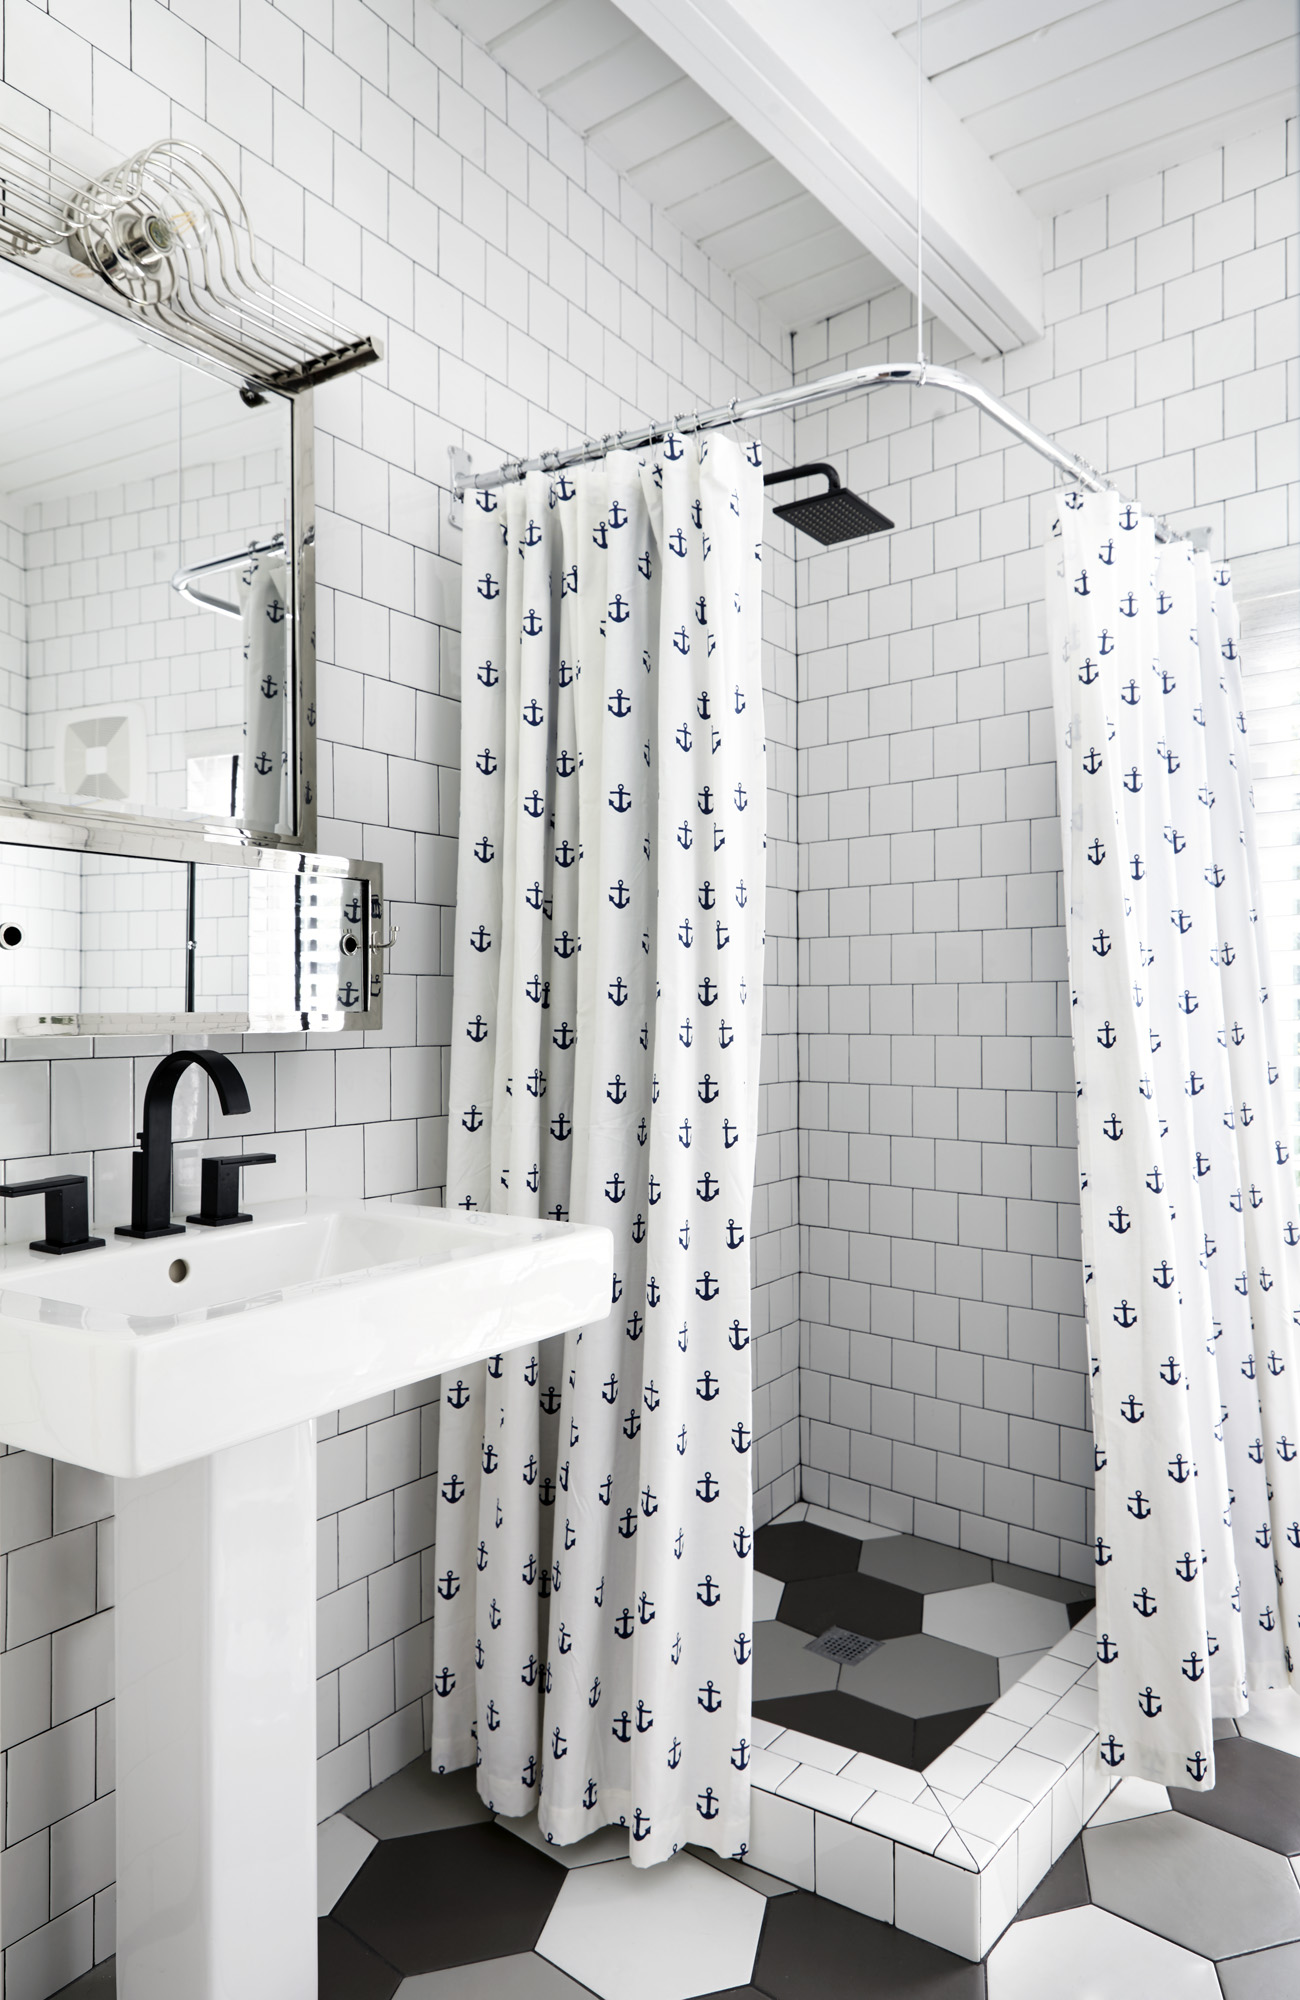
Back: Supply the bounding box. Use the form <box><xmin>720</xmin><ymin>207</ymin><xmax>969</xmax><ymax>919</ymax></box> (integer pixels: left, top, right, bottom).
<box><xmin>742</xmin><ymin>1890</ymin><xmax>986</xmax><ymax>2000</ymax></box>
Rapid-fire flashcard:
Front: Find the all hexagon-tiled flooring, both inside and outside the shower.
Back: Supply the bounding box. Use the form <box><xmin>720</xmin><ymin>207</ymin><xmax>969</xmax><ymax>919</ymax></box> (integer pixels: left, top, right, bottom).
<box><xmin>58</xmin><ymin>1524</ymin><xmax>1300</xmax><ymax>2000</ymax></box>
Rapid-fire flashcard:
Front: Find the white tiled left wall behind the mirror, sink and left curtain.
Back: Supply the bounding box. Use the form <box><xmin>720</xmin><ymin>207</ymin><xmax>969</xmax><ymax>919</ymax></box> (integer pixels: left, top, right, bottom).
<box><xmin>0</xmin><ymin>0</ymin><xmax>798</xmax><ymax>2000</ymax></box>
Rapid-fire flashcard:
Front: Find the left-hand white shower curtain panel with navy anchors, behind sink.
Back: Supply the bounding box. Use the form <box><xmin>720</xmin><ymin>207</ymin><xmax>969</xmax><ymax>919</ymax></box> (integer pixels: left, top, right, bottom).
<box><xmin>432</xmin><ymin>436</ymin><xmax>764</xmax><ymax>1866</ymax></box>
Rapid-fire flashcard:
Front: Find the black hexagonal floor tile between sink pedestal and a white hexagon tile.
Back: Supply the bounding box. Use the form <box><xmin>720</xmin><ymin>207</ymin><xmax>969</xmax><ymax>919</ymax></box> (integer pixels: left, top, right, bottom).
<box><xmin>332</xmin><ymin>1826</ymin><xmax>566</xmax><ymax>1974</ymax></box>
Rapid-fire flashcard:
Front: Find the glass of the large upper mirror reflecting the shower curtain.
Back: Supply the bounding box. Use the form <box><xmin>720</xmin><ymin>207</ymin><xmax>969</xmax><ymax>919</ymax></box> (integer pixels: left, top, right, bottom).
<box><xmin>0</xmin><ymin>262</ymin><xmax>292</xmax><ymax>836</ymax></box>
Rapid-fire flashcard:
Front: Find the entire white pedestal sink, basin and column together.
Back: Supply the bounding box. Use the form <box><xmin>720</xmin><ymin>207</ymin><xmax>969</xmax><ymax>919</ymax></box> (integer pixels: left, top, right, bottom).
<box><xmin>0</xmin><ymin>1202</ymin><xmax>612</xmax><ymax>2000</ymax></box>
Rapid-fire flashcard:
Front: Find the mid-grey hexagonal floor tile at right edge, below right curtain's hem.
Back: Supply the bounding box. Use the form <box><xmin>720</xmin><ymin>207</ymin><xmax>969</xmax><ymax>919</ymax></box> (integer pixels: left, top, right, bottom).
<box><xmin>1084</xmin><ymin>1812</ymin><xmax>1300</xmax><ymax>1958</ymax></box>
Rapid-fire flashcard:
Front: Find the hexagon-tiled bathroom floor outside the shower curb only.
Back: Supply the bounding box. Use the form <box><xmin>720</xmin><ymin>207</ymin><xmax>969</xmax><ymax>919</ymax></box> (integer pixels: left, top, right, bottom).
<box><xmin>50</xmin><ymin>1702</ymin><xmax>1300</xmax><ymax>2000</ymax></box>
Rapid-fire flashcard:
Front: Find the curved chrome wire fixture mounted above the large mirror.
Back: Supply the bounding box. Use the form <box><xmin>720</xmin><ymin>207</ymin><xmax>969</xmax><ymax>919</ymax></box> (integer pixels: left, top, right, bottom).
<box><xmin>0</xmin><ymin>128</ymin><xmax>382</xmax><ymax>392</ymax></box>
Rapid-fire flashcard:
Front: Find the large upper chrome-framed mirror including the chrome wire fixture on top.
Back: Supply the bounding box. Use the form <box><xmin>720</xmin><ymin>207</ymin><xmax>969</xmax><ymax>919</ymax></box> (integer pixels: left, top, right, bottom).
<box><xmin>0</xmin><ymin>130</ymin><xmax>380</xmax><ymax>852</ymax></box>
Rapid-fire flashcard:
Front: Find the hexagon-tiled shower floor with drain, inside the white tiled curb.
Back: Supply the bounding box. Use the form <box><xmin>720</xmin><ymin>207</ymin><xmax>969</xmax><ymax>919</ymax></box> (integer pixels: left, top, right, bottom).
<box><xmin>754</xmin><ymin>1520</ymin><xmax>1094</xmax><ymax>1770</ymax></box>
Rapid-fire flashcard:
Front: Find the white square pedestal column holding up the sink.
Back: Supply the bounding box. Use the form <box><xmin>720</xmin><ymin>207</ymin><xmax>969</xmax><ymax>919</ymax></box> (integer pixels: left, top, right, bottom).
<box><xmin>116</xmin><ymin>1424</ymin><xmax>316</xmax><ymax>2000</ymax></box>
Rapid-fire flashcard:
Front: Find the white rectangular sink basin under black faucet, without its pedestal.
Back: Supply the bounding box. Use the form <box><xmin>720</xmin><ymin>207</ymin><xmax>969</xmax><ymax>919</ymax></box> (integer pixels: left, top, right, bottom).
<box><xmin>0</xmin><ymin>1200</ymin><xmax>610</xmax><ymax>1478</ymax></box>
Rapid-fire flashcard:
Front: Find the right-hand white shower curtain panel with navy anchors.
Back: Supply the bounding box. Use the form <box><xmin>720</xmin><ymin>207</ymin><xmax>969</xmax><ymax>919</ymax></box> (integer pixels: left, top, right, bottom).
<box><xmin>1048</xmin><ymin>492</ymin><xmax>1300</xmax><ymax>1790</ymax></box>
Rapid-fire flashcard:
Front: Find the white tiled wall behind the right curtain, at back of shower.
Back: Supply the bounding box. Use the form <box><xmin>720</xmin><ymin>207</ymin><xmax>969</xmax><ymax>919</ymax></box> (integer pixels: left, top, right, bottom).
<box><xmin>794</xmin><ymin>120</ymin><xmax>1300</xmax><ymax>1578</ymax></box>
